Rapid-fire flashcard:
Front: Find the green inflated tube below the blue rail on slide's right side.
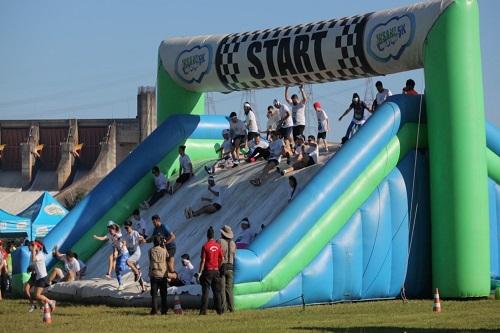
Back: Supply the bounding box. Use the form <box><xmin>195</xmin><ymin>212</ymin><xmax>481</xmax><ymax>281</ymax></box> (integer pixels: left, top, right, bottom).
<box><xmin>234</xmin><ymin>124</ymin><xmax>427</xmax><ymax>309</ymax></box>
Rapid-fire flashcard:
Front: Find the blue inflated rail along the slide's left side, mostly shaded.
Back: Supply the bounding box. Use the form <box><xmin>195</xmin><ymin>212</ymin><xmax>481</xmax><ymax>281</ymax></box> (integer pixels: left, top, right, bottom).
<box><xmin>41</xmin><ymin>115</ymin><xmax>229</xmax><ymax>273</ymax></box>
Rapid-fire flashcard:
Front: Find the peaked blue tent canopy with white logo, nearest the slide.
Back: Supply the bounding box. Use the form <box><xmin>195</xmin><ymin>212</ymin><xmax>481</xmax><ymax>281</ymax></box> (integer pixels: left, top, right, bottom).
<box><xmin>19</xmin><ymin>192</ymin><xmax>68</xmax><ymax>240</ymax></box>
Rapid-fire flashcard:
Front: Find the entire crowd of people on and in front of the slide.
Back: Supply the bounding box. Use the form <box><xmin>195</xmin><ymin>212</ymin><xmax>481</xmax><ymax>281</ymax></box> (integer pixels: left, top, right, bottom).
<box><xmin>11</xmin><ymin>79</ymin><xmax>417</xmax><ymax>314</ymax></box>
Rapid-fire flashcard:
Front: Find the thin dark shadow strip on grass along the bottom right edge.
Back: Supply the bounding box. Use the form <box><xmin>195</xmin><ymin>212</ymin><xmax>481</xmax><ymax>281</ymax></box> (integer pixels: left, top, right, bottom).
<box><xmin>291</xmin><ymin>327</ymin><xmax>500</xmax><ymax>333</ymax></box>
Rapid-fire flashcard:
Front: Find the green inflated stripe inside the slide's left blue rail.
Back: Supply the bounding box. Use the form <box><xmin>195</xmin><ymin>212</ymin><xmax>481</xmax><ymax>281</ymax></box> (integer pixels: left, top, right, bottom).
<box><xmin>72</xmin><ymin>139</ymin><xmax>220</xmax><ymax>260</ymax></box>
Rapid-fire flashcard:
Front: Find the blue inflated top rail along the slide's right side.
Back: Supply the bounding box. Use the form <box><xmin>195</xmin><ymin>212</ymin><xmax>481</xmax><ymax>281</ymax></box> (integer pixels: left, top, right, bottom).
<box><xmin>235</xmin><ymin>96</ymin><xmax>421</xmax><ymax>283</ymax></box>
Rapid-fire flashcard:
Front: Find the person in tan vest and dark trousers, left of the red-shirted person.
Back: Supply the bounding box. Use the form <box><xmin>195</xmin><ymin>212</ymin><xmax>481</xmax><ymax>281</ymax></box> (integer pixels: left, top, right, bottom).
<box><xmin>148</xmin><ymin>235</ymin><xmax>168</xmax><ymax>315</ymax></box>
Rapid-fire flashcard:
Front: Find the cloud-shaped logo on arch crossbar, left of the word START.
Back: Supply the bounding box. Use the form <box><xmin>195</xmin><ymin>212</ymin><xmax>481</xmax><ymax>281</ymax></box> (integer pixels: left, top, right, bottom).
<box><xmin>175</xmin><ymin>45</ymin><xmax>212</xmax><ymax>83</ymax></box>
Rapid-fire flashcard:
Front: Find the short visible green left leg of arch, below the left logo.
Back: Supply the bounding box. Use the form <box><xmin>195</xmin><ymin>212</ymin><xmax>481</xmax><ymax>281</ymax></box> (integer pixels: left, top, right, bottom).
<box><xmin>156</xmin><ymin>57</ymin><xmax>205</xmax><ymax>125</ymax></box>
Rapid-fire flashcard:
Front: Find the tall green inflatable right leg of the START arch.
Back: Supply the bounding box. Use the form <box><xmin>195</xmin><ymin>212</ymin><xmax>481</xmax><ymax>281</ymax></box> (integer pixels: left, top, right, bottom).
<box><xmin>424</xmin><ymin>0</ymin><xmax>490</xmax><ymax>298</ymax></box>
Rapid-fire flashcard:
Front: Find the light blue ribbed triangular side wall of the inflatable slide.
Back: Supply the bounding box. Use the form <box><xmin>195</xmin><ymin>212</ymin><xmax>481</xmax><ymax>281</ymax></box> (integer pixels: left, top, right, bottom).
<box><xmin>263</xmin><ymin>153</ymin><xmax>431</xmax><ymax>308</ymax></box>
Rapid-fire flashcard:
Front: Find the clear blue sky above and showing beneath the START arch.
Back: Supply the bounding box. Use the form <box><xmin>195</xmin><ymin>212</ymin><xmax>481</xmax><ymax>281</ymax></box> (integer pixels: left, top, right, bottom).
<box><xmin>0</xmin><ymin>0</ymin><xmax>500</xmax><ymax>139</ymax></box>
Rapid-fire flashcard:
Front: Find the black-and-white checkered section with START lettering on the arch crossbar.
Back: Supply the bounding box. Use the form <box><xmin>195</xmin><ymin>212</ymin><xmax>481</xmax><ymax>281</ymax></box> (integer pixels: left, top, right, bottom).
<box><xmin>215</xmin><ymin>14</ymin><xmax>377</xmax><ymax>90</ymax></box>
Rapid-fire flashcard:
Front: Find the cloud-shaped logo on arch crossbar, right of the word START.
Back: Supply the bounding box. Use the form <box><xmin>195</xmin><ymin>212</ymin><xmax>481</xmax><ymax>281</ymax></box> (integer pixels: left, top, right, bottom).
<box><xmin>367</xmin><ymin>13</ymin><xmax>415</xmax><ymax>62</ymax></box>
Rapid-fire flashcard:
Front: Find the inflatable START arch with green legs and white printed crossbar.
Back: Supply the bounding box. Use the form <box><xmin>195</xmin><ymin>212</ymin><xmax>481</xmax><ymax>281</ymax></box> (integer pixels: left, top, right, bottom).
<box><xmin>157</xmin><ymin>0</ymin><xmax>492</xmax><ymax>307</ymax></box>
